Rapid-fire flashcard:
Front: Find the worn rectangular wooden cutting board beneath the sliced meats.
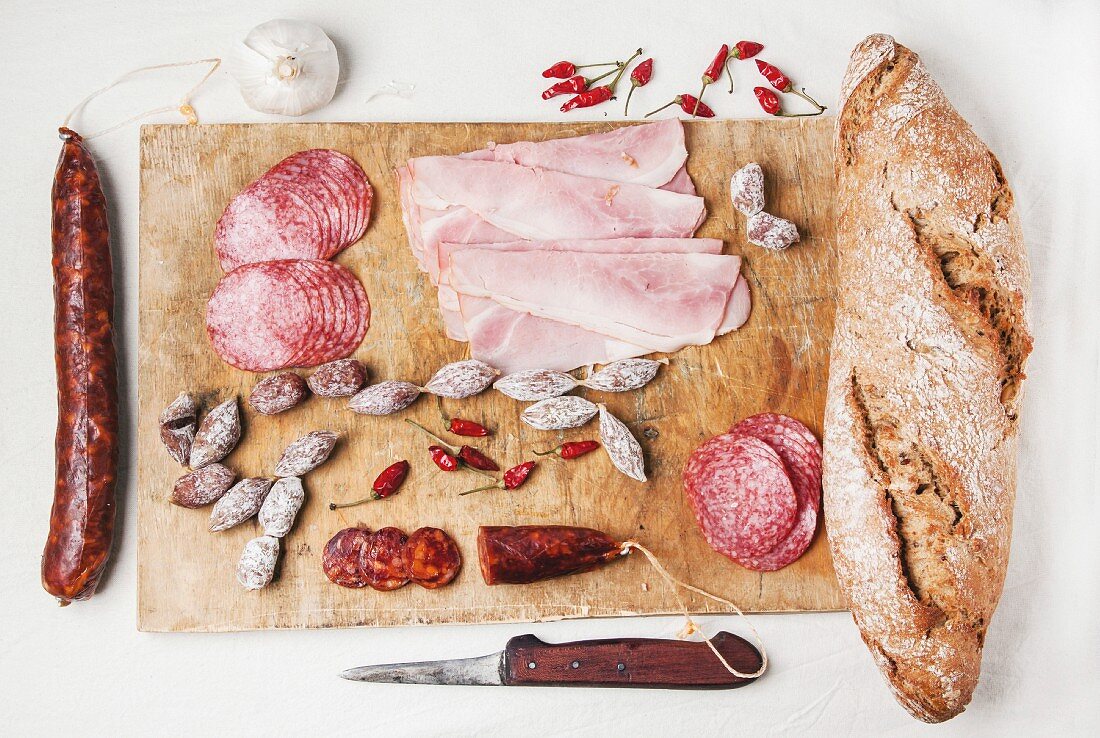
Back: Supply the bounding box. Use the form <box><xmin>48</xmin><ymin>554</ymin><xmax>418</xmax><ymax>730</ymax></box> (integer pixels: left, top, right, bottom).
<box><xmin>138</xmin><ymin>119</ymin><xmax>844</xmax><ymax>631</ymax></box>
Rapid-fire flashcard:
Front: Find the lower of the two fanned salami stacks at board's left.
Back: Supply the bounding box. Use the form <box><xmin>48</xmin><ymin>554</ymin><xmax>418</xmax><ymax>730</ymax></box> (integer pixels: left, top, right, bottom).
<box><xmin>207</xmin><ymin>260</ymin><xmax>371</xmax><ymax>372</ymax></box>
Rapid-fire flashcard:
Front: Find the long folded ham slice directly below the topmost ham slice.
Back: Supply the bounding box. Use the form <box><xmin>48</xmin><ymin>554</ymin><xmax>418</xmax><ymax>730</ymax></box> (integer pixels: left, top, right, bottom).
<box><xmin>409</xmin><ymin>156</ymin><xmax>706</xmax><ymax>240</ymax></box>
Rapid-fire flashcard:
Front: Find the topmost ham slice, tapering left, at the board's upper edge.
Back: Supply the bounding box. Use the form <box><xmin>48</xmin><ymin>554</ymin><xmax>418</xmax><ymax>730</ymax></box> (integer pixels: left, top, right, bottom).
<box><xmin>460</xmin><ymin>118</ymin><xmax>695</xmax><ymax>189</ymax></box>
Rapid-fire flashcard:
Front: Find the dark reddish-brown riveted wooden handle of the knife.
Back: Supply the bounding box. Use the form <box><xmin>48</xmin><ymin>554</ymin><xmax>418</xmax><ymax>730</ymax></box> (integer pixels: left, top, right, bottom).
<box><xmin>502</xmin><ymin>631</ymin><xmax>761</xmax><ymax>690</ymax></box>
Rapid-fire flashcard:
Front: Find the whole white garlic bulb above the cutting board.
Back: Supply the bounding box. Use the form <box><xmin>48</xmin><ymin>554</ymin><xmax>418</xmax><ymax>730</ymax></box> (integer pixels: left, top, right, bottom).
<box><xmin>229</xmin><ymin>19</ymin><xmax>340</xmax><ymax>115</ymax></box>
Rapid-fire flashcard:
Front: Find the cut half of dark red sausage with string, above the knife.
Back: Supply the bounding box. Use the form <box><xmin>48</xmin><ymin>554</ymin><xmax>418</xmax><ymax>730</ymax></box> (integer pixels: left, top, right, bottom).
<box><xmin>477</xmin><ymin>526</ymin><xmax>624</xmax><ymax>585</ymax></box>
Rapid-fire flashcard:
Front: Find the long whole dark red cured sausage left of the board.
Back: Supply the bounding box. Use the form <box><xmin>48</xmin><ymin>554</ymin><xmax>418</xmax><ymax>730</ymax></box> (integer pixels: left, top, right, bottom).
<box><xmin>42</xmin><ymin>128</ymin><xmax>119</xmax><ymax>605</ymax></box>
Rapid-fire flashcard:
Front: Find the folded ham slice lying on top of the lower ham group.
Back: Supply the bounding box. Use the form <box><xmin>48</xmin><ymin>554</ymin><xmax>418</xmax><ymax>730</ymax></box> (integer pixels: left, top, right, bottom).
<box><xmin>450</xmin><ymin>249</ymin><xmax>740</xmax><ymax>352</ymax></box>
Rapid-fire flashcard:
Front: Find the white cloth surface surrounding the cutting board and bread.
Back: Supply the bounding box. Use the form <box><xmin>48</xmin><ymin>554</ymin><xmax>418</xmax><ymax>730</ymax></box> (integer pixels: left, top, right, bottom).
<box><xmin>0</xmin><ymin>0</ymin><xmax>1100</xmax><ymax>736</ymax></box>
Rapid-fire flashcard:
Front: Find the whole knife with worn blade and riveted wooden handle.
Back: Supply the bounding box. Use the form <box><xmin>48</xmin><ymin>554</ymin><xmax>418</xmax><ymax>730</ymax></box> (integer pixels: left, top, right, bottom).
<box><xmin>340</xmin><ymin>631</ymin><xmax>761</xmax><ymax>690</ymax></box>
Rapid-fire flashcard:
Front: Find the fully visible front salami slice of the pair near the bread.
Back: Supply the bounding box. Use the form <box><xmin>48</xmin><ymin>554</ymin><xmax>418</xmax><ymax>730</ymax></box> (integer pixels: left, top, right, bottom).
<box><xmin>683</xmin><ymin>433</ymin><xmax>798</xmax><ymax>561</ymax></box>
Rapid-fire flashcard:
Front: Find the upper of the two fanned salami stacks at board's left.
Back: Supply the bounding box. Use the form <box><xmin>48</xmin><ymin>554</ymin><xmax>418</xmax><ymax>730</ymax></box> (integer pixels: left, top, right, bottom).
<box><xmin>215</xmin><ymin>148</ymin><xmax>374</xmax><ymax>272</ymax></box>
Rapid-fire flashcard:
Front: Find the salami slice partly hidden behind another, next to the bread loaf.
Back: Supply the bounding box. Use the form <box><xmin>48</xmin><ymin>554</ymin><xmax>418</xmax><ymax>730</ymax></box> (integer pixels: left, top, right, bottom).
<box><xmin>729</xmin><ymin>412</ymin><xmax>822</xmax><ymax>571</ymax></box>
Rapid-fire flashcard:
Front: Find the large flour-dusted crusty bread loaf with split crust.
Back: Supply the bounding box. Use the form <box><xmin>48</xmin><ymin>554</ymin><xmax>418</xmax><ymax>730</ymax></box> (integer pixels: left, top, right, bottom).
<box><xmin>824</xmin><ymin>35</ymin><xmax>1032</xmax><ymax>723</ymax></box>
